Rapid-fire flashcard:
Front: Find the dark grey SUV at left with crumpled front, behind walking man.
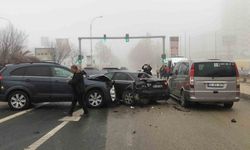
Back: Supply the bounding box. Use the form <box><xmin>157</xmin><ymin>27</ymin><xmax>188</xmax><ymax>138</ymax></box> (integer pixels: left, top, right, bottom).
<box><xmin>0</xmin><ymin>63</ymin><xmax>115</xmax><ymax>110</ymax></box>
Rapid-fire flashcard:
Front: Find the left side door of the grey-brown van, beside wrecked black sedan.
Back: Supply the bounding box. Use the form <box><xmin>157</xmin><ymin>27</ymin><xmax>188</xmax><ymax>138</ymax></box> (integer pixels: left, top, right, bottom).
<box><xmin>169</xmin><ymin>63</ymin><xmax>180</xmax><ymax>95</ymax></box>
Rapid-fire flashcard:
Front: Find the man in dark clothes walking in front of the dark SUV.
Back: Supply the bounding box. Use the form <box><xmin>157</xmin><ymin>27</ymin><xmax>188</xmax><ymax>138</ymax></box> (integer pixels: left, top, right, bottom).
<box><xmin>69</xmin><ymin>65</ymin><xmax>88</xmax><ymax>116</ymax></box>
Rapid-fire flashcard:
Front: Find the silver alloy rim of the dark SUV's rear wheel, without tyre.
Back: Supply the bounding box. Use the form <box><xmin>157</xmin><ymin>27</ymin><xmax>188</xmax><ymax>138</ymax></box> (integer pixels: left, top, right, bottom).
<box><xmin>10</xmin><ymin>93</ymin><xmax>27</xmax><ymax>109</ymax></box>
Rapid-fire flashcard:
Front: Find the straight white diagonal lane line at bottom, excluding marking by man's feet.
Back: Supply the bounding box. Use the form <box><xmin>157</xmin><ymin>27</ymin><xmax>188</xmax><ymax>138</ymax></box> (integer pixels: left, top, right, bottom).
<box><xmin>24</xmin><ymin>121</ymin><xmax>69</xmax><ymax>150</ymax></box>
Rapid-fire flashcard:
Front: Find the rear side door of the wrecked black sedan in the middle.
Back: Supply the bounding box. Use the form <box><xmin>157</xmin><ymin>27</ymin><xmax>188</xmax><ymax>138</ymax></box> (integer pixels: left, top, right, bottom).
<box><xmin>112</xmin><ymin>72</ymin><xmax>134</xmax><ymax>99</ymax></box>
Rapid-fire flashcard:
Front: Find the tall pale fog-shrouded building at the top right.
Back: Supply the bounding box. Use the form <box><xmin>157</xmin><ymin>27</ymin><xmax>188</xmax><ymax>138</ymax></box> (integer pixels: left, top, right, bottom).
<box><xmin>222</xmin><ymin>0</ymin><xmax>250</xmax><ymax>59</ymax></box>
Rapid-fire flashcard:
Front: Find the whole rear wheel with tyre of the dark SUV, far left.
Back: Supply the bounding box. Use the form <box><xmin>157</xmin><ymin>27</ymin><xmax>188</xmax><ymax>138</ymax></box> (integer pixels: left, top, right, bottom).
<box><xmin>8</xmin><ymin>91</ymin><xmax>31</xmax><ymax>110</ymax></box>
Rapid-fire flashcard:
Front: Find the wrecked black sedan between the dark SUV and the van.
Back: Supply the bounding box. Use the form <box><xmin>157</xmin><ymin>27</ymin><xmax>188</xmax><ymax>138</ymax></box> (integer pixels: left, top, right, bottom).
<box><xmin>105</xmin><ymin>71</ymin><xmax>169</xmax><ymax>105</ymax></box>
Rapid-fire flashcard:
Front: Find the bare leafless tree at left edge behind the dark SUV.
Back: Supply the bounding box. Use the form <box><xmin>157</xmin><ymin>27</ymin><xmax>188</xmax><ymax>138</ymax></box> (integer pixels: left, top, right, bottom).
<box><xmin>0</xmin><ymin>25</ymin><xmax>38</xmax><ymax>65</ymax></box>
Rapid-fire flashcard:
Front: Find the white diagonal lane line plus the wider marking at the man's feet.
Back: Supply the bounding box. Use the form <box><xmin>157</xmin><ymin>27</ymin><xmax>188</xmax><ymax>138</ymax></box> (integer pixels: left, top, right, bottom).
<box><xmin>24</xmin><ymin>109</ymin><xmax>83</xmax><ymax>150</ymax></box>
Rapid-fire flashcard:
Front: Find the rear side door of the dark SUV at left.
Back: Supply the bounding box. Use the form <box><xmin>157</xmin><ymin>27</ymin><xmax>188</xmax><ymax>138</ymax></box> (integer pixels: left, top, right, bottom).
<box><xmin>24</xmin><ymin>65</ymin><xmax>52</xmax><ymax>101</ymax></box>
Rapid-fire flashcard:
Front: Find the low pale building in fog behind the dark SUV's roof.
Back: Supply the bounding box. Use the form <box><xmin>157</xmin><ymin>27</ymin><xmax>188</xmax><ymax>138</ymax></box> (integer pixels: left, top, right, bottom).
<box><xmin>35</xmin><ymin>48</ymin><xmax>55</xmax><ymax>61</ymax></box>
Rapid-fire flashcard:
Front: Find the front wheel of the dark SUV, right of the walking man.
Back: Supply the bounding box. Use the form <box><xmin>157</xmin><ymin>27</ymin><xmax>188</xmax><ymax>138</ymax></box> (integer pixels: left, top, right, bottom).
<box><xmin>86</xmin><ymin>90</ymin><xmax>104</xmax><ymax>108</ymax></box>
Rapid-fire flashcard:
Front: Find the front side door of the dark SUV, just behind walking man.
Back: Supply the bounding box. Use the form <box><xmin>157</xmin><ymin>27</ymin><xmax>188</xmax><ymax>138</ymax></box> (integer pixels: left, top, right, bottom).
<box><xmin>51</xmin><ymin>66</ymin><xmax>73</xmax><ymax>101</ymax></box>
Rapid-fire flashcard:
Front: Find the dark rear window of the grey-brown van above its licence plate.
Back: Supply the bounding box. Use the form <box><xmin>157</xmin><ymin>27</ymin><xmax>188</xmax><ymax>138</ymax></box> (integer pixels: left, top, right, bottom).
<box><xmin>194</xmin><ymin>62</ymin><xmax>236</xmax><ymax>77</ymax></box>
